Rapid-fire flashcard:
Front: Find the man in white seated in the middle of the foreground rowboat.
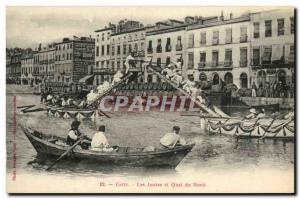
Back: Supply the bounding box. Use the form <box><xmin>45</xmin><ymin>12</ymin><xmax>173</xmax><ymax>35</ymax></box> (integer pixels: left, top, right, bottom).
<box><xmin>91</xmin><ymin>125</ymin><xmax>115</xmax><ymax>152</ymax></box>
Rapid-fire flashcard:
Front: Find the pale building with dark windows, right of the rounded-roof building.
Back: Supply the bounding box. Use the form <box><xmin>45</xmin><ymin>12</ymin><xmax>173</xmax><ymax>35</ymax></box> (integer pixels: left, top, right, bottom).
<box><xmin>144</xmin><ymin>17</ymin><xmax>189</xmax><ymax>82</ymax></box>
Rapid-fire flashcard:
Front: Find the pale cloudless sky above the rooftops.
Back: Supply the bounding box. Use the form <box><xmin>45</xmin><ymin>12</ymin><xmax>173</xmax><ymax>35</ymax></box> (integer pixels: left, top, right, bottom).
<box><xmin>6</xmin><ymin>6</ymin><xmax>282</xmax><ymax>48</ymax></box>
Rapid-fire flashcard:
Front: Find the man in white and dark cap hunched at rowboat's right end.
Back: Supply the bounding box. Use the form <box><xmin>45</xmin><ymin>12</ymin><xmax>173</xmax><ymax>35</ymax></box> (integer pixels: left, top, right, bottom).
<box><xmin>160</xmin><ymin>126</ymin><xmax>186</xmax><ymax>148</ymax></box>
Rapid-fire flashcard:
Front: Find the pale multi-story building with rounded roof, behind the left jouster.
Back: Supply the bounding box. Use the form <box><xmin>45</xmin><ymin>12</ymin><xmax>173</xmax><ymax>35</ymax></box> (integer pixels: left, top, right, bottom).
<box><xmin>110</xmin><ymin>20</ymin><xmax>146</xmax><ymax>82</ymax></box>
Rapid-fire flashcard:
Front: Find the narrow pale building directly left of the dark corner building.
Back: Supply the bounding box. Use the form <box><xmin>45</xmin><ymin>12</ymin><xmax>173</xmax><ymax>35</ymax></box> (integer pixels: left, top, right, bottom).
<box><xmin>38</xmin><ymin>43</ymin><xmax>55</xmax><ymax>81</ymax></box>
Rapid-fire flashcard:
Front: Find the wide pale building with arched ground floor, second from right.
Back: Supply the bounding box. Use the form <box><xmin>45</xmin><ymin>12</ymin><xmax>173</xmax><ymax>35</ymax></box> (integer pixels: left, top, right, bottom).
<box><xmin>185</xmin><ymin>14</ymin><xmax>250</xmax><ymax>90</ymax></box>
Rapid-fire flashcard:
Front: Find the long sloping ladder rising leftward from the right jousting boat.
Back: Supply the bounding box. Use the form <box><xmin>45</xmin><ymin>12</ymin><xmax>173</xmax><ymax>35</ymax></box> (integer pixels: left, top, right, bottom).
<box><xmin>149</xmin><ymin>65</ymin><xmax>219</xmax><ymax>117</ymax></box>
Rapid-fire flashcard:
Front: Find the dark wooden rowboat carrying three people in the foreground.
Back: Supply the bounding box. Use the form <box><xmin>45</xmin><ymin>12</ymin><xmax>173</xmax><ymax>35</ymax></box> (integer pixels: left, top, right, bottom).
<box><xmin>22</xmin><ymin>127</ymin><xmax>195</xmax><ymax>168</ymax></box>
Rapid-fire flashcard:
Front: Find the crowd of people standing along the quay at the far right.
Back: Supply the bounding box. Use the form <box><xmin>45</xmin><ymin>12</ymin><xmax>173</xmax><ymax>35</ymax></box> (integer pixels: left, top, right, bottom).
<box><xmin>251</xmin><ymin>81</ymin><xmax>294</xmax><ymax>98</ymax></box>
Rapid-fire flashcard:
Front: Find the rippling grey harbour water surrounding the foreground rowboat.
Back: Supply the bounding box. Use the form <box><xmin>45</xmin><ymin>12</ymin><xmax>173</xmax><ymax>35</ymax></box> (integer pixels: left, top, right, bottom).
<box><xmin>6</xmin><ymin>86</ymin><xmax>294</xmax><ymax>192</ymax></box>
